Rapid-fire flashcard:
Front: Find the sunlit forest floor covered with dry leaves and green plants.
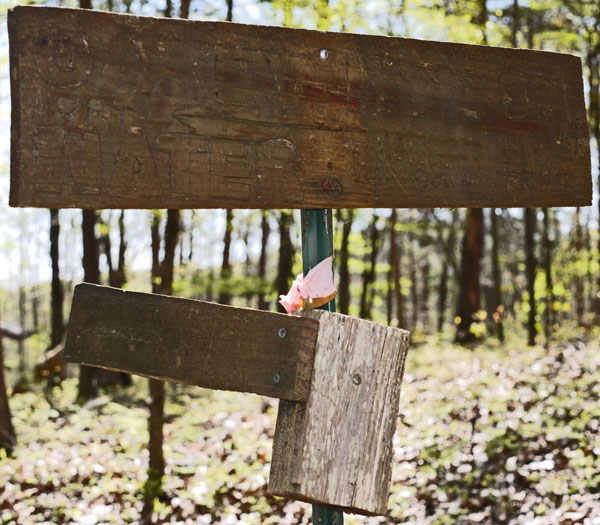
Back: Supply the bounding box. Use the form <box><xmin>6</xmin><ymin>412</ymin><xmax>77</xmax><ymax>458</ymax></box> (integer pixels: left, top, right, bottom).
<box><xmin>0</xmin><ymin>330</ymin><xmax>600</xmax><ymax>525</ymax></box>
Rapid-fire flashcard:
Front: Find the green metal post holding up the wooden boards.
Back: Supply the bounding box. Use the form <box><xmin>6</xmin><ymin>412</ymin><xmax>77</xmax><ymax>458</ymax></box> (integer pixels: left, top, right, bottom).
<box><xmin>301</xmin><ymin>209</ymin><xmax>344</xmax><ymax>525</ymax></box>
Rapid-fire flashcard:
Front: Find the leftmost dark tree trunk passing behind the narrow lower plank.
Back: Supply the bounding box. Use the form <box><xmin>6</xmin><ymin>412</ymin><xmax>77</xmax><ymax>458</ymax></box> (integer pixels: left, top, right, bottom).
<box><xmin>77</xmin><ymin>210</ymin><xmax>100</xmax><ymax>402</ymax></box>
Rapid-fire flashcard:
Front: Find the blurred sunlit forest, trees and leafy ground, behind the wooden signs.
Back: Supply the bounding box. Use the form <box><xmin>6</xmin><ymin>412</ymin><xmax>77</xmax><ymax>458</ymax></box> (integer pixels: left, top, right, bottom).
<box><xmin>0</xmin><ymin>0</ymin><xmax>600</xmax><ymax>525</ymax></box>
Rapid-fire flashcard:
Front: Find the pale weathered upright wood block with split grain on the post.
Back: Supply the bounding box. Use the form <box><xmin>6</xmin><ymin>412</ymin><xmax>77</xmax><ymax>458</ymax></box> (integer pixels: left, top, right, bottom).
<box><xmin>269</xmin><ymin>310</ymin><xmax>408</xmax><ymax>514</ymax></box>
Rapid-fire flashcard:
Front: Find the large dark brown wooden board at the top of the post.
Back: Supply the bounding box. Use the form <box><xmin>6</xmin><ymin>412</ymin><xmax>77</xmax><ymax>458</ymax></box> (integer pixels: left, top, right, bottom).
<box><xmin>8</xmin><ymin>7</ymin><xmax>592</xmax><ymax>208</ymax></box>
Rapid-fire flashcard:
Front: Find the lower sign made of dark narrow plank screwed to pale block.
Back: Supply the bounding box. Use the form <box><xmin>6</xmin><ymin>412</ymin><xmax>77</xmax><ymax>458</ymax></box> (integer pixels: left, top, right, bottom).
<box><xmin>63</xmin><ymin>284</ymin><xmax>408</xmax><ymax>514</ymax></box>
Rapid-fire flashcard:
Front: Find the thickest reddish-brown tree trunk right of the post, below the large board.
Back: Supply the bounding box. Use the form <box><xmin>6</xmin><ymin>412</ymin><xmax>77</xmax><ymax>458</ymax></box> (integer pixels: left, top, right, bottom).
<box><xmin>456</xmin><ymin>208</ymin><xmax>483</xmax><ymax>344</ymax></box>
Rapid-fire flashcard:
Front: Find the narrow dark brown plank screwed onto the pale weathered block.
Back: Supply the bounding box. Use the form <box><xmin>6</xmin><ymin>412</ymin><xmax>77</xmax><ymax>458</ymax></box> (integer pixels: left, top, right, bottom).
<box><xmin>63</xmin><ymin>284</ymin><xmax>319</xmax><ymax>401</ymax></box>
